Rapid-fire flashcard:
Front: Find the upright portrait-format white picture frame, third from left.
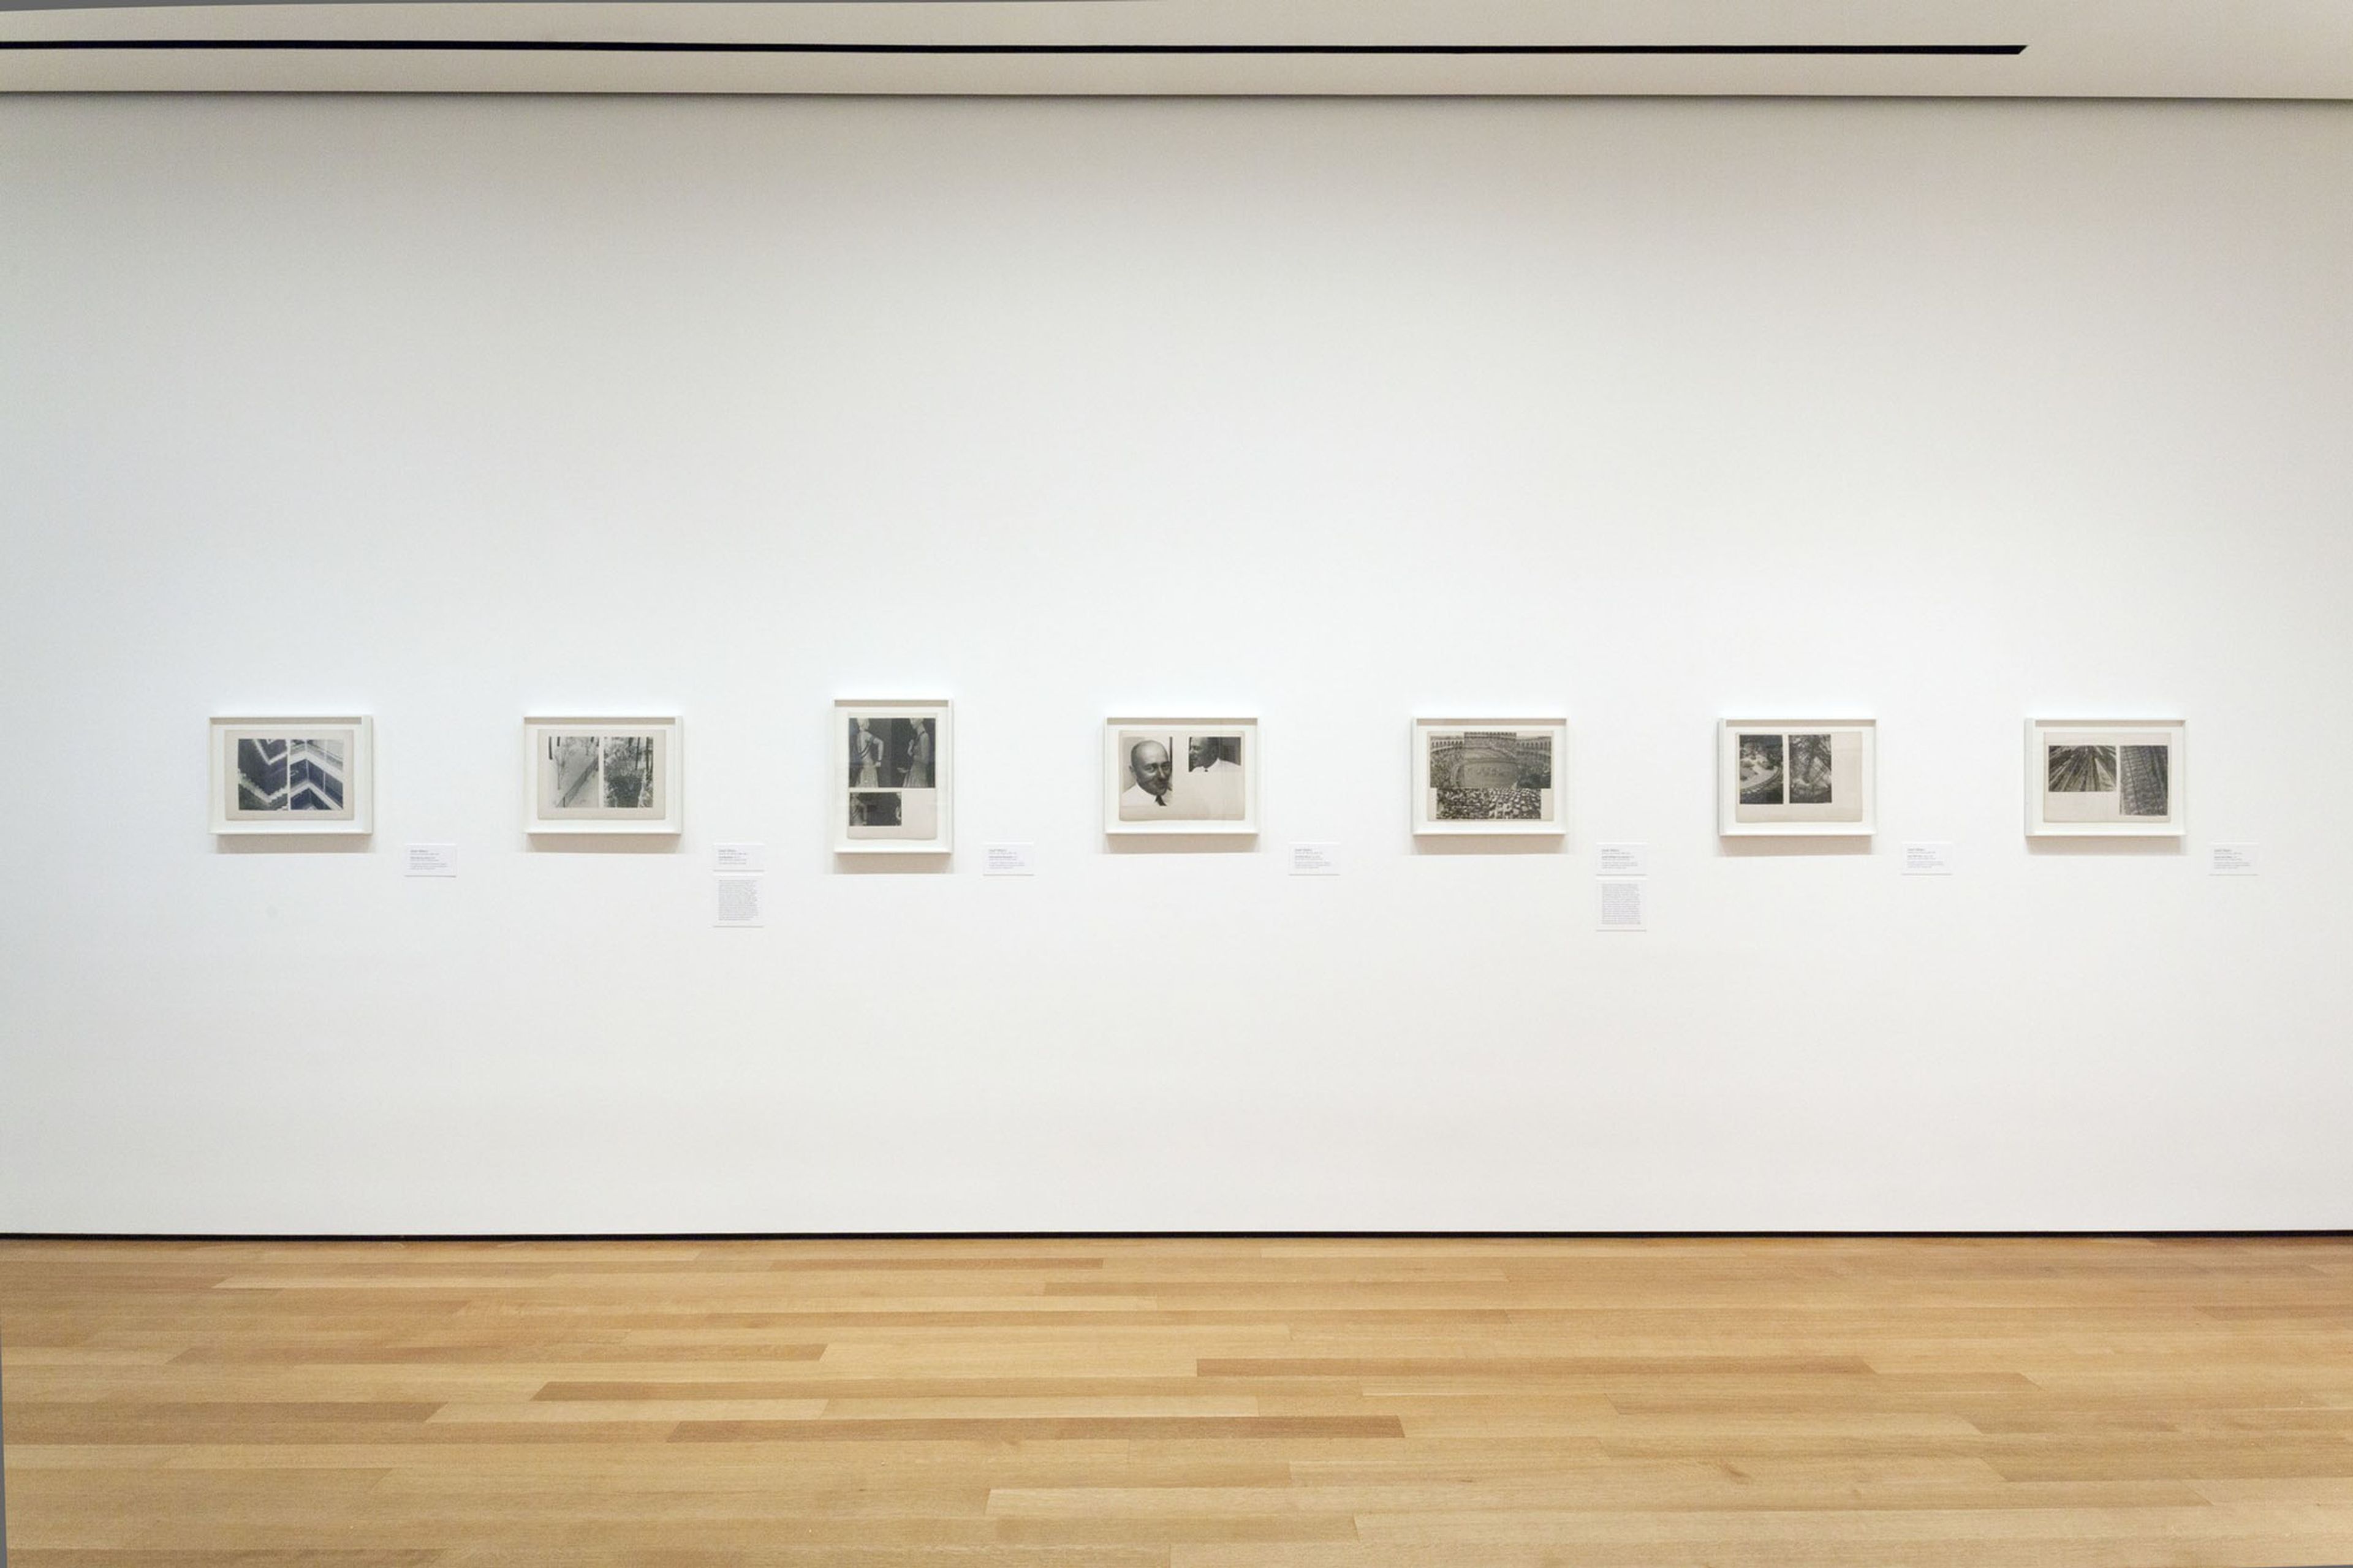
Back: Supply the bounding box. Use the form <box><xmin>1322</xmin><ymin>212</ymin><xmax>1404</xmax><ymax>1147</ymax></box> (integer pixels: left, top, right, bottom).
<box><xmin>826</xmin><ymin>697</ymin><xmax>955</xmax><ymax>855</ymax></box>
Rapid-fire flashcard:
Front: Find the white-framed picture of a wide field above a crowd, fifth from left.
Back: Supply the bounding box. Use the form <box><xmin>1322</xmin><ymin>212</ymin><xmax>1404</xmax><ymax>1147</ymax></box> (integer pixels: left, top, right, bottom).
<box><xmin>1412</xmin><ymin>716</ymin><xmax>1569</xmax><ymax>838</ymax></box>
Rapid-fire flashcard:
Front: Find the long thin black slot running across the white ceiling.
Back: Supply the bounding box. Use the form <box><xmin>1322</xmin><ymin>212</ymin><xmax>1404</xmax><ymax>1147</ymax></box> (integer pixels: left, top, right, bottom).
<box><xmin>0</xmin><ymin>37</ymin><xmax>2026</xmax><ymax>59</ymax></box>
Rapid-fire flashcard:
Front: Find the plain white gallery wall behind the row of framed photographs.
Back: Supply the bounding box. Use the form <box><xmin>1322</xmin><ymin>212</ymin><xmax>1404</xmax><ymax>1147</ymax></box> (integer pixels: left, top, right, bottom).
<box><xmin>0</xmin><ymin>97</ymin><xmax>2353</xmax><ymax>1233</ymax></box>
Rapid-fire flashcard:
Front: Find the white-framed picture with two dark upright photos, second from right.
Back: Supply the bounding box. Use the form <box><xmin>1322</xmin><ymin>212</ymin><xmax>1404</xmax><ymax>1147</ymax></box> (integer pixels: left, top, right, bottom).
<box><xmin>1715</xmin><ymin>718</ymin><xmax>1880</xmax><ymax>838</ymax></box>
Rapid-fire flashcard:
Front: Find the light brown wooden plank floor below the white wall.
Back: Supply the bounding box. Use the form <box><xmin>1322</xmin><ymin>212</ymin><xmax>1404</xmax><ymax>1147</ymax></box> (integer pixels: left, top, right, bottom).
<box><xmin>0</xmin><ymin>1241</ymin><xmax>2353</xmax><ymax>1568</ymax></box>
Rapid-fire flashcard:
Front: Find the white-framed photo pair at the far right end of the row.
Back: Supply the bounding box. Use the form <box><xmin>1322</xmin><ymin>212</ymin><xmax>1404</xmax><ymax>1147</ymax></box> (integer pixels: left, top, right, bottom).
<box><xmin>2026</xmin><ymin>718</ymin><xmax>2191</xmax><ymax>838</ymax></box>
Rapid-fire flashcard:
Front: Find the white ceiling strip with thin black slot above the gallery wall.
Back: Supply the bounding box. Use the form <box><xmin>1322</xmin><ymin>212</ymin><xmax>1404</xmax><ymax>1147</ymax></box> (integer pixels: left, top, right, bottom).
<box><xmin>0</xmin><ymin>0</ymin><xmax>2353</xmax><ymax>99</ymax></box>
